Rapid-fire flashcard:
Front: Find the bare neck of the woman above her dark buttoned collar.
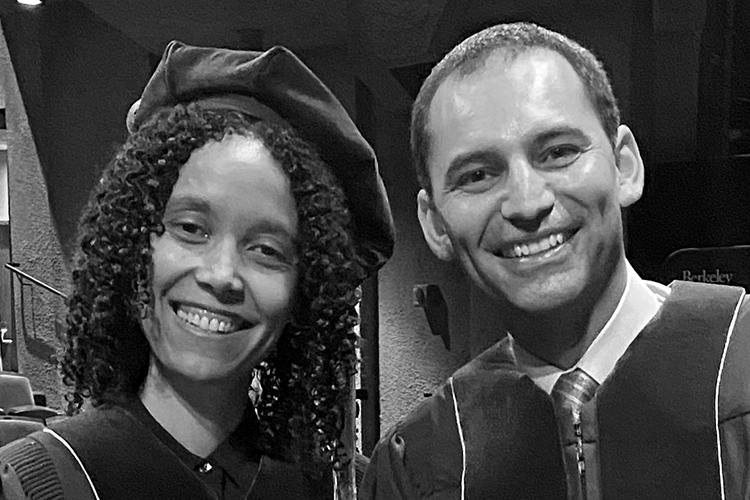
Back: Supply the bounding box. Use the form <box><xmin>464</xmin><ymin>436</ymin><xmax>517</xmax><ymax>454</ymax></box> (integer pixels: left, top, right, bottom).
<box><xmin>140</xmin><ymin>359</ymin><xmax>254</xmax><ymax>458</ymax></box>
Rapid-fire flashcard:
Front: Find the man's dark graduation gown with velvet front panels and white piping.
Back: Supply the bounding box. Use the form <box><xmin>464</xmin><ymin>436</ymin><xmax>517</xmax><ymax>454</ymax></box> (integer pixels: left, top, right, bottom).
<box><xmin>360</xmin><ymin>282</ymin><xmax>750</xmax><ymax>500</ymax></box>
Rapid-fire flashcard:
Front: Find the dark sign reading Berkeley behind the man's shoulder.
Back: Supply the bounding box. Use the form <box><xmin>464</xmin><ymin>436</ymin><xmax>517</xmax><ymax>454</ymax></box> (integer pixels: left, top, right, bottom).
<box><xmin>662</xmin><ymin>245</ymin><xmax>750</xmax><ymax>292</ymax></box>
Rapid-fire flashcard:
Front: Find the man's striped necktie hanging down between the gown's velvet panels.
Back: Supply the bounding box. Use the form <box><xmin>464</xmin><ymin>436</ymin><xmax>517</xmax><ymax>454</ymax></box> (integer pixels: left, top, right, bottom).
<box><xmin>552</xmin><ymin>368</ymin><xmax>599</xmax><ymax>500</ymax></box>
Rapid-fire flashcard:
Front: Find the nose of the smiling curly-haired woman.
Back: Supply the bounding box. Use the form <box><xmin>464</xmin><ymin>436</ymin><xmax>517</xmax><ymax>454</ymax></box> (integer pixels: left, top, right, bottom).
<box><xmin>196</xmin><ymin>238</ymin><xmax>244</xmax><ymax>301</ymax></box>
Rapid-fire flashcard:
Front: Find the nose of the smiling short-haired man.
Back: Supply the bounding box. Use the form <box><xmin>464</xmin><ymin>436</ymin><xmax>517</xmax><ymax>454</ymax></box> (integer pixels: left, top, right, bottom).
<box><xmin>500</xmin><ymin>156</ymin><xmax>555</xmax><ymax>230</ymax></box>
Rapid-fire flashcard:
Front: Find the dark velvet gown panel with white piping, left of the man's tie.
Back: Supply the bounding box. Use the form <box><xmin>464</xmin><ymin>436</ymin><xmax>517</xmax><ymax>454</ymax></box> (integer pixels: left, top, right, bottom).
<box><xmin>453</xmin><ymin>365</ymin><xmax>568</xmax><ymax>500</ymax></box>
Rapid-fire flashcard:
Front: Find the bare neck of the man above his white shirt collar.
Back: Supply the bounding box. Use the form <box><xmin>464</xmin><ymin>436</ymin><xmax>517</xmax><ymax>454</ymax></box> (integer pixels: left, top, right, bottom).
<box><xmin>508</xmin><ymin>261</ymin><xmax>628</xmax><ymax>370</ymax></box>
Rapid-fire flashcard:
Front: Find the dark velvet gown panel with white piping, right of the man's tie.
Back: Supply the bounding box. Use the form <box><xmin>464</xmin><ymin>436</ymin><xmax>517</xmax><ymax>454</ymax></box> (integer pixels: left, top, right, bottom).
<box><xmin>595</xmin><ymin>282</ymin><xmax>745</xmax><ymax>500</ymax></box>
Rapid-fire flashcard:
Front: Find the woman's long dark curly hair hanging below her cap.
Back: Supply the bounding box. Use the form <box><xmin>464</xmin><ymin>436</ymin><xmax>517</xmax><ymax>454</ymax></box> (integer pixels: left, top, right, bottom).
<box><xmin>61</xmin><ymin>104</ymin><xmax>365</xmax><ymax>464</ymax></box>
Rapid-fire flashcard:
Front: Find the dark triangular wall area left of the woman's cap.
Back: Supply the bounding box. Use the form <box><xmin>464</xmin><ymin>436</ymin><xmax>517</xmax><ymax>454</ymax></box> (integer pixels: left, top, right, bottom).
<box><xmin>3</xmin><ymin>2</ymin><xmax>151</xmax><ymax>258</ymax></box>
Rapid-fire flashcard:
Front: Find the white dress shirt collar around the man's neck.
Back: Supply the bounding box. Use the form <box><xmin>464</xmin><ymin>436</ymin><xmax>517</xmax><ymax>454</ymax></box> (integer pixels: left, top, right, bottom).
<box><xmin>508</xmin><ymin>262</ymin><xmax>670</xmax><ymax>394</ymax></box>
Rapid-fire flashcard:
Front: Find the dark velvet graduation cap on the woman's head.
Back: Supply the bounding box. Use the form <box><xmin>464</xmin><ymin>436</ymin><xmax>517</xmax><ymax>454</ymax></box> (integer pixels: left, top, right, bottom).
<box><xmin>127</xmin><ymin>41</ymin><xmax>394</xmax><ymax>273</ymax></box>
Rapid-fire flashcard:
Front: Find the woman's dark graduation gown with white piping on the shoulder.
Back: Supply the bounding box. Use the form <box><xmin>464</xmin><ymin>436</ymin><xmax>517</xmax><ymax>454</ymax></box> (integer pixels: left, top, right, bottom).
<box><xmin>0</xmin><ymin>405</ymin><xmax>332</xmax><ymax>500</ymax></box>
